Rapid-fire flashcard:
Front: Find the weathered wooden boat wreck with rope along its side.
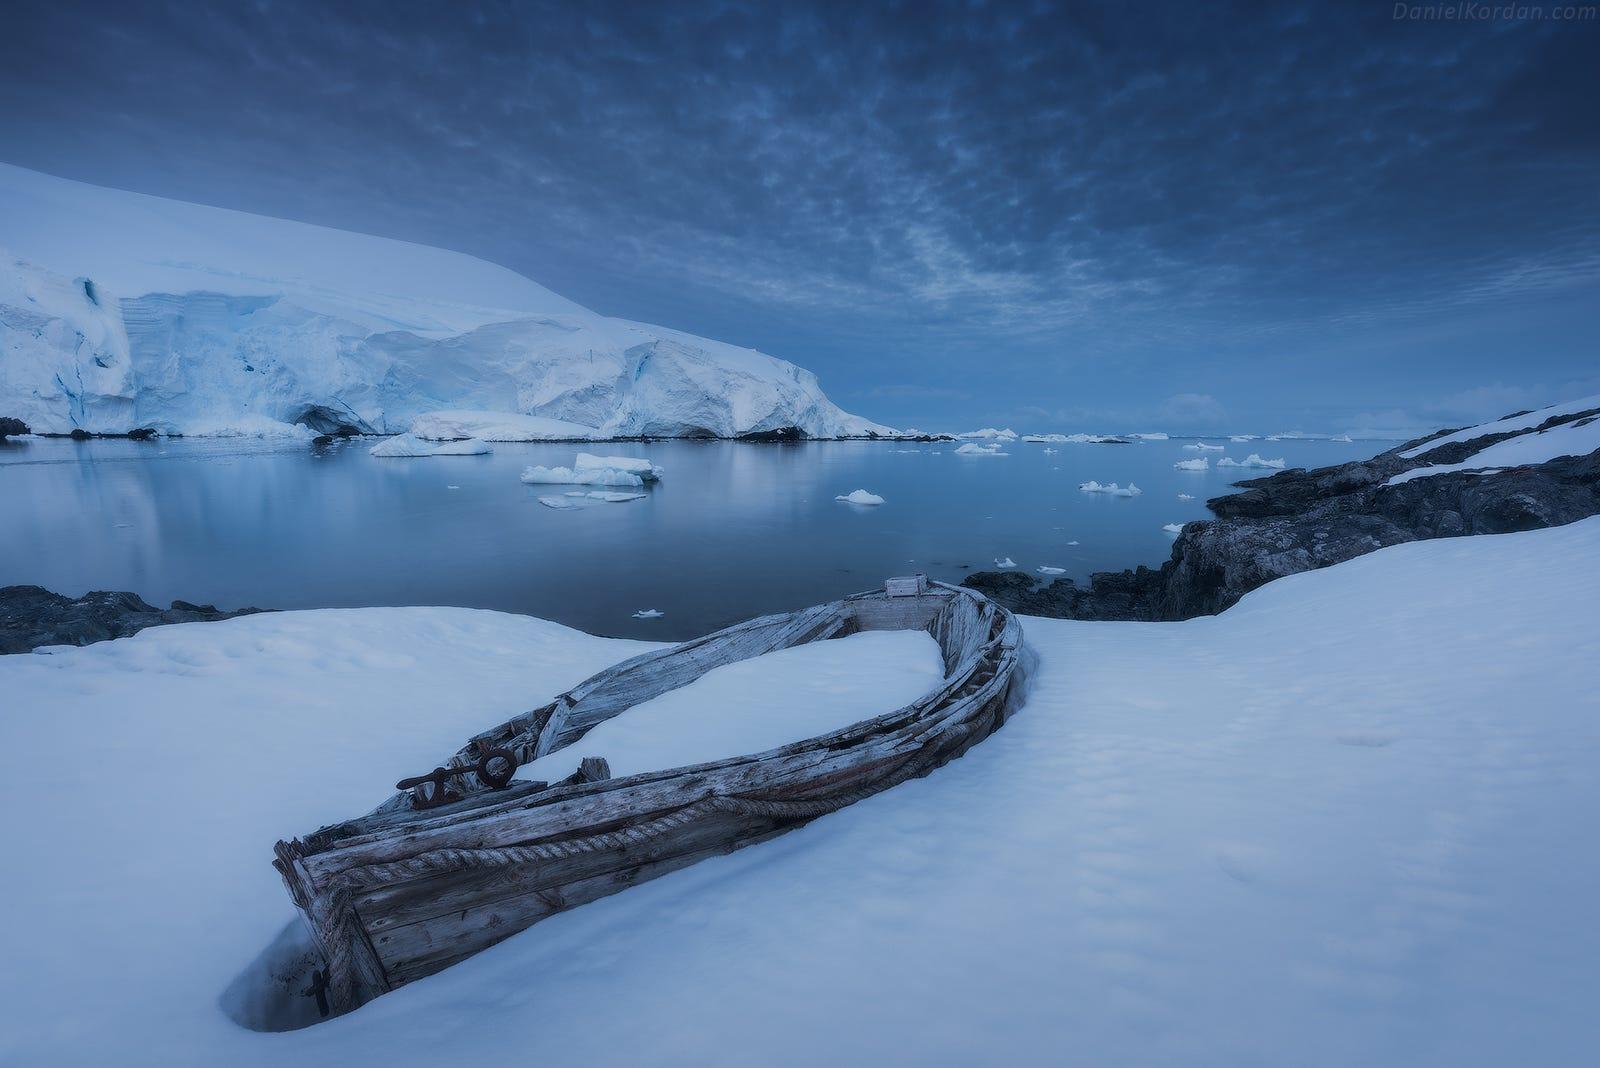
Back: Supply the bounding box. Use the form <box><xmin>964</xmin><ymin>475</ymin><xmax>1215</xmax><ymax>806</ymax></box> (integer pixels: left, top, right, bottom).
<box><xmin>274</xmin><ymin>576</ymin><xmax>1022</xmax><ymax>1012</ymax></box>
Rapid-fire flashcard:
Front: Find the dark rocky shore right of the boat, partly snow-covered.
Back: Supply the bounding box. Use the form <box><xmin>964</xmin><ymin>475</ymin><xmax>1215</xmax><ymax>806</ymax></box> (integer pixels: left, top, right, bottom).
<box><xmin>963</xmin><ymin>399</ymin><xmax>1600</xmax><ymax>620</ymax></box>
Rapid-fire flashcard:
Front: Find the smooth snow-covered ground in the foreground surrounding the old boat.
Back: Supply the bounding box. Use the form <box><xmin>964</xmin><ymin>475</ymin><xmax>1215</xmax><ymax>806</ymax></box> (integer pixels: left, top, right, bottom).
<box><xmin>0</xmin><ymin>518</ymin><xmax>1600</xmax><ymax>1068</ymax></box>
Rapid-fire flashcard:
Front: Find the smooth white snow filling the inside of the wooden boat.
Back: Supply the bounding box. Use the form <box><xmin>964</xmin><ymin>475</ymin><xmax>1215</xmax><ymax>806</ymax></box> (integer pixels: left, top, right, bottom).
<box><xmin>517</xmin><ymin>629</ymin><xmax>944</xmax><ymax>782</ymax></box>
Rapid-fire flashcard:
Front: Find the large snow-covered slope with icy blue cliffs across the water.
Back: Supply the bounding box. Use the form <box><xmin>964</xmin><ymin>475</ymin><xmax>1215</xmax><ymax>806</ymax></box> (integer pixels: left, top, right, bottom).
<box><xmin>0</xmin><ymin>165</ymin><xmax>886</xmax><ymax>436</ymax></box>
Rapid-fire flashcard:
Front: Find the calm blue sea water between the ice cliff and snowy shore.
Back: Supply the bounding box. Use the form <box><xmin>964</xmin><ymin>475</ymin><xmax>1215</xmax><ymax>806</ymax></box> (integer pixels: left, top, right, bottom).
<box><xmin>0</xmin><ymin>440</ymin><xmax>1387</xmax><ymax>640</ymax></box>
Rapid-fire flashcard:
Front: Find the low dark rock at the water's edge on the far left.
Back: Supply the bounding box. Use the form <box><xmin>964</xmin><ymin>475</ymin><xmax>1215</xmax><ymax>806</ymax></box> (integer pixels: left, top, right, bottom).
<box><xmin>0</xmin><ymin>585</ymin><xmax>262</xmax><ymax>654</ymax></box>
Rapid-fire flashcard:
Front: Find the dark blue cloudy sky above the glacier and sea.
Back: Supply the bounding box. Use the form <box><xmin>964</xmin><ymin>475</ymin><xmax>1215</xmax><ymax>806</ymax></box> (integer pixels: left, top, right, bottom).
<box><xmin>0</xmin><ymin>0</ymin><xmax>1600</xmax><ymax>432</ymax></box>
